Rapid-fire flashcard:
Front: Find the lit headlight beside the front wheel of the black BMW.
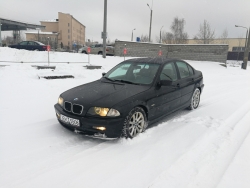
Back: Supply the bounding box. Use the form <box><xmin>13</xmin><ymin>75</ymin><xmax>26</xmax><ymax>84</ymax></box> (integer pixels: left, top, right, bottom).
<box><xmin>87</xmin><ymin>107</ymin><xmax>120</xmax><ymax>117</ymax></box>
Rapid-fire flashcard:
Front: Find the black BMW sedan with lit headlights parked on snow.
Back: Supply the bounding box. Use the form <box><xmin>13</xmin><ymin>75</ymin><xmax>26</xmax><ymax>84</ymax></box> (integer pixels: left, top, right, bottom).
<box><xmin>54</xmin><ymin>58</ymin><xmax>204</xmax><ymax>138</ymax></box>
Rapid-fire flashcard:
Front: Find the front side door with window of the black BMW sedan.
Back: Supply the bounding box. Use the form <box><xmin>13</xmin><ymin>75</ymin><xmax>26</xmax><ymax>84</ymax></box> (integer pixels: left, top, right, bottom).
<box><xmin>148</xmin><ymin>62</ymin><xmax>181</xmax><ymax>117</ymax></box>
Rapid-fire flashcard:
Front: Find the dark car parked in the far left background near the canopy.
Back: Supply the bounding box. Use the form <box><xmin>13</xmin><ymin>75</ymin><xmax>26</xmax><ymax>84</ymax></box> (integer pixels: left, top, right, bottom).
<box><xmin>9</xmin><ymin>41</ymin><xmax>47</xmax><ymax>51</ymax></box>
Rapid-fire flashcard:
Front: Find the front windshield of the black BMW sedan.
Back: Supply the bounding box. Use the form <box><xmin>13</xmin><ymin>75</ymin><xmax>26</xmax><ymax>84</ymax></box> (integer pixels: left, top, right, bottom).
<box><xmin>104</xmin><ymin>62</ymin><xmax>160</xmax><ymax>84</ymax></box>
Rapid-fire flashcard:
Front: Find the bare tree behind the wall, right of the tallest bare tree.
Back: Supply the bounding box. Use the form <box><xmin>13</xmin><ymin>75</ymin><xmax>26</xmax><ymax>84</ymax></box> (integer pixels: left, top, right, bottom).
<box><xmin>194</xmin><ymin>20</ymin><xmax>215</xmax><ymax>44</ymax></box>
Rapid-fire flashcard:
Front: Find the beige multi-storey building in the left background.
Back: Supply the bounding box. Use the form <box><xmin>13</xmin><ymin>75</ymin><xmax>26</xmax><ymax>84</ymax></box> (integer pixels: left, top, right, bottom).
<box><xmin>26</xmin><ymin>12</ymin><xmax>85</xmax><ymax>49</ymax></box>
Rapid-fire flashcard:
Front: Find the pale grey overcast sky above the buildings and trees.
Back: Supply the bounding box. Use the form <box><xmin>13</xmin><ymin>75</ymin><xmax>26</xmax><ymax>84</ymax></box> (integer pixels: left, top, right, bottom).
<box><xmin>0</xmin><ymin>0</ymin><xmax>250</xmax><ymax>42</ymax></box>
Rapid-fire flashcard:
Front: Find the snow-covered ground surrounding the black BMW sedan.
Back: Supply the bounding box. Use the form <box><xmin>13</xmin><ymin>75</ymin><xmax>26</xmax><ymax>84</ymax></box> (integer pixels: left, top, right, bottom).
<box><xmin>0</xmin><ymin>48</ymin><xmax>250</xmax><ymax>188</ymax></box>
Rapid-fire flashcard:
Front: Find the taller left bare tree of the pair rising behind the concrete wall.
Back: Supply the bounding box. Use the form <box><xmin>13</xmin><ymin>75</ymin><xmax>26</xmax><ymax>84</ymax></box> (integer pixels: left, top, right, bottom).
<box><xmin>170</xmin><ymin>17</ymin><xmax>188</xmax><ymax>44</ymax></box>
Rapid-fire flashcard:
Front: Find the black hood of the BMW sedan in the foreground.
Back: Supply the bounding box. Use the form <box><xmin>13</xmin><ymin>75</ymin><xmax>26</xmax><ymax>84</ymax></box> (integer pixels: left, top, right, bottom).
<box><xmin>61</xmin><ymin>80</ymin><xmax>149</xmax><ymax>109</ymax></box>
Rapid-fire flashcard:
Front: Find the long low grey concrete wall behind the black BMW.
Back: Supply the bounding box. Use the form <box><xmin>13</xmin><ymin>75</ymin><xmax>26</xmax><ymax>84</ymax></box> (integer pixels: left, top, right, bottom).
<box><xmin>115</xmin><ymin>41</ymin><xmax>228</xmax><ymax>63</ymax></box>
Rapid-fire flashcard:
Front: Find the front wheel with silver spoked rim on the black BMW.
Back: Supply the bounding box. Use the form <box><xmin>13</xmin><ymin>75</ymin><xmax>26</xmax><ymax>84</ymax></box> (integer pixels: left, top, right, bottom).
<box><xmin>123</xmin><ymin>107</ymin><xmax>148</xmax><ymax>138</ymax></box>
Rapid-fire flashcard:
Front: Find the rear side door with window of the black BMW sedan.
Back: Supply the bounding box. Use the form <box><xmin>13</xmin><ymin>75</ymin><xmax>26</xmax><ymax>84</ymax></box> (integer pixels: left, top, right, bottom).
<box><xmin>176</xmin><ymin>61</ymin><xmax>195</xmax><ymax>105</ymax></box>
